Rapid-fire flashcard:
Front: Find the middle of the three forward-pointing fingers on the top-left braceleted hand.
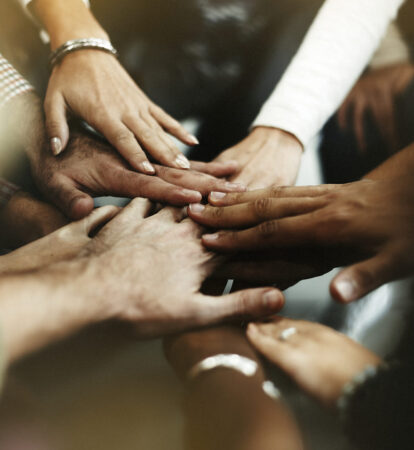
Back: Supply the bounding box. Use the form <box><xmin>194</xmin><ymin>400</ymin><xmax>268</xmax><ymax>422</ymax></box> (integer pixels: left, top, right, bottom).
<box><xmin>128</xmin><ymin>116</ymin><xmax>190</xmax><ymax>169</ymax></box>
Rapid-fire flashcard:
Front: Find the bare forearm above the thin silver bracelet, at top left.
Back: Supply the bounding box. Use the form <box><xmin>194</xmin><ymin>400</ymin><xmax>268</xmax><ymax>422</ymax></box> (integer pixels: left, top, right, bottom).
<box><xmin>29</xmin><ymin>0</ymin><xmax>108</xmax><ymax>50</ymax></box>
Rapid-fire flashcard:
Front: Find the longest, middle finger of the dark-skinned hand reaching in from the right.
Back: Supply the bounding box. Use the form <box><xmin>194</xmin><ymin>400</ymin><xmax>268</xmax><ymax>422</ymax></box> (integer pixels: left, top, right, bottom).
<box><xmin>188</xmin><ymin>197</ymin><xmax>326</xmax><ymax>228</ymax></box>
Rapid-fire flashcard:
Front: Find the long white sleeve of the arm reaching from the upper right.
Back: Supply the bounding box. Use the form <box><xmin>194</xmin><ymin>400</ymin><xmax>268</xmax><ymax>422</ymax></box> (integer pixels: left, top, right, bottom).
<box><xmin>253</xmin><ymin>0</ymin><xmax>404</xmax><ymax>147</ymax></box>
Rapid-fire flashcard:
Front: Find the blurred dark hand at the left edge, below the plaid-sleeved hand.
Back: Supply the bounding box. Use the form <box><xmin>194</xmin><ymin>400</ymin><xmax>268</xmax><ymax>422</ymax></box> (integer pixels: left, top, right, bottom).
<box><xmin>0</xmin><ymin>191</ymin><xmax>67</xmax><ymax>250</ymax></box>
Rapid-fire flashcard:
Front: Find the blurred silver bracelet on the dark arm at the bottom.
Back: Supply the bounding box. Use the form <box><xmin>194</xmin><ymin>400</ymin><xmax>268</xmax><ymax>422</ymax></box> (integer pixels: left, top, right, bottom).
<box><xmin>187</xmin><ymin>353</ymin><xmax>281</xmax><ymax>400</ymax></box>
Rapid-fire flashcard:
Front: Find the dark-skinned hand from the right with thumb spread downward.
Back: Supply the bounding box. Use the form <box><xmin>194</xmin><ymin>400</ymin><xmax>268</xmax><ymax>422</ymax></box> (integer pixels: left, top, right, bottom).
<box><xmin>189</xmin><ymin>174</ymin><xmax>414</xmax><ymax>302</ymax></box>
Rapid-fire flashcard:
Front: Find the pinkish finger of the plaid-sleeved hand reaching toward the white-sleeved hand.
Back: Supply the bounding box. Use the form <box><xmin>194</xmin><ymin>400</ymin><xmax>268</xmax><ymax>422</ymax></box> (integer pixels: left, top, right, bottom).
<box><xmin>155</xmin><ymin>165</ymin><xmax>246</xmax><ymax>196</ymax></box>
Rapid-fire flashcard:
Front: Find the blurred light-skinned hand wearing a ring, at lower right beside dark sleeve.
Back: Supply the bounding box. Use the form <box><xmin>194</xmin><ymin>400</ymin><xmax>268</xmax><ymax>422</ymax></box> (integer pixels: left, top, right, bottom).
<box><xmin>247</xmin><ymin>317</ymin><xmax>381</xmax><ymax>407</ymax></box>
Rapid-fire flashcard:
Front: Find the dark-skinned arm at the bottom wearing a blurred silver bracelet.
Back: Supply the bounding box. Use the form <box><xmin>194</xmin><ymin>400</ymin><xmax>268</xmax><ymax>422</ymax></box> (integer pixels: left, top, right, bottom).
<box><xmin>165</xmin><ymin>327</ymin><xmax>303</xmax><ymax>450</ymax></box>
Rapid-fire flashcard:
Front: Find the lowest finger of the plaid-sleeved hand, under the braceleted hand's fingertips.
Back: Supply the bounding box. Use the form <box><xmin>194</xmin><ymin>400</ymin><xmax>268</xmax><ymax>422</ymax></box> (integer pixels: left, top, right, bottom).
<box><xmin>108</xmin><ymin>168</ymin><xmax>202</xmax><ymax>206</ymax></box>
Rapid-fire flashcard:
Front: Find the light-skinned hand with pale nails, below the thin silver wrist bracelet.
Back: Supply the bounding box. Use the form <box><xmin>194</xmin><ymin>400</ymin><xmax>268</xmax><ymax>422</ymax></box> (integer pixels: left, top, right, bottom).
<box><xmin>45</xmin><ymin>50</ymin><xmax>198</xmax><ymax>174</ymax></box>
